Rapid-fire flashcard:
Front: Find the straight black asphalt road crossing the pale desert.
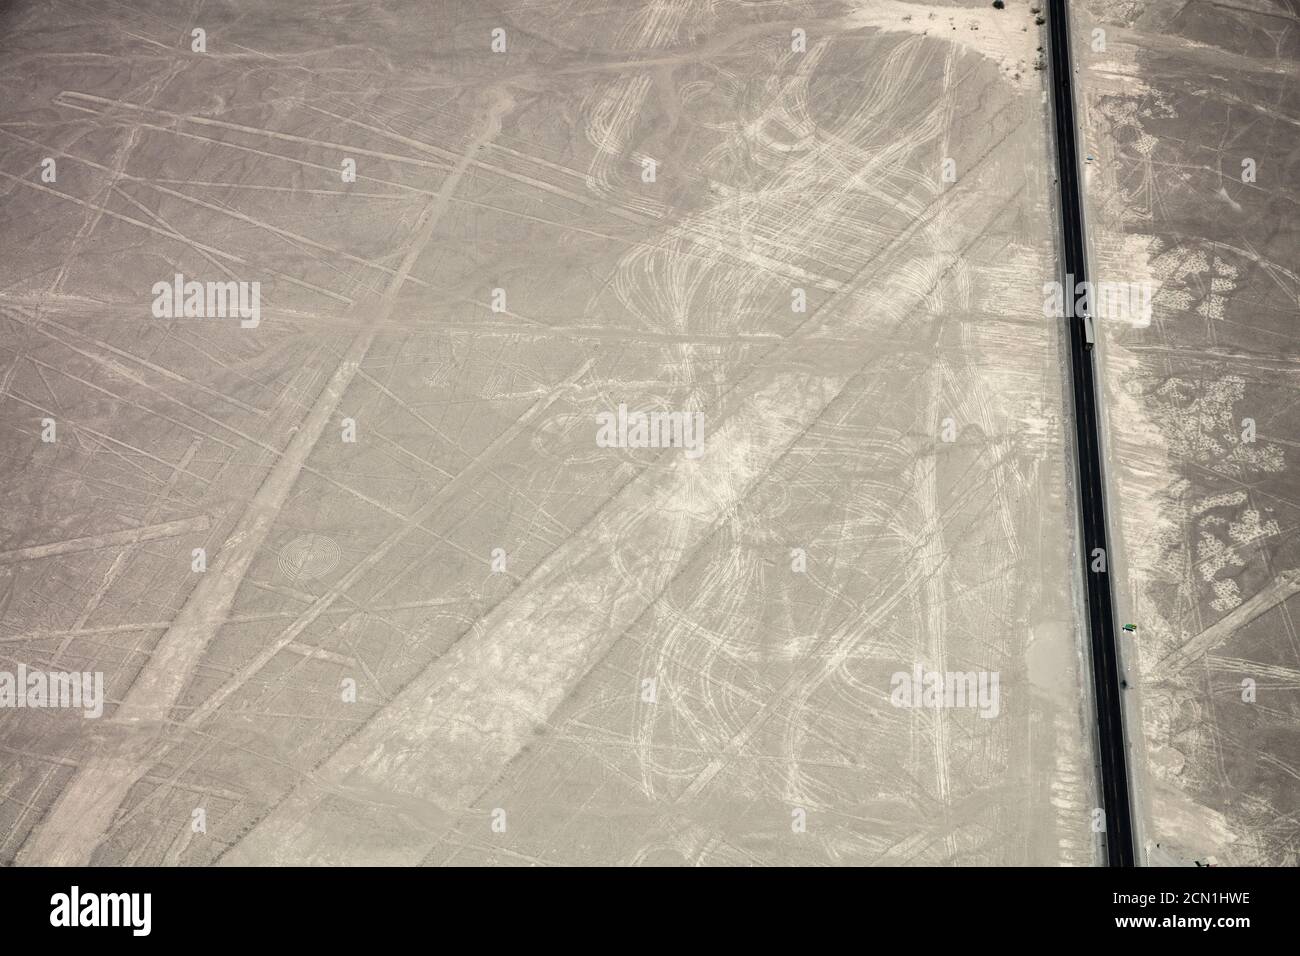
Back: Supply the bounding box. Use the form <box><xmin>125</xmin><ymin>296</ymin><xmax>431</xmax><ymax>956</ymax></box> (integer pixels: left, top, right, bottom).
<box><xmin>1049</xmin><ymin>0</ymin><xmax>1134</xmax><ymax>866</ymax></box>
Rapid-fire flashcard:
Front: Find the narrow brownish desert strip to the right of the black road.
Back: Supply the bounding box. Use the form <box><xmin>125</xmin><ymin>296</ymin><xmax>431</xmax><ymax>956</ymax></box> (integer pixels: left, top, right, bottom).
<box><xmin>1075</xmin><ymin>0</ymin><xmax>1300</xmax><ymax>866</ymax></box>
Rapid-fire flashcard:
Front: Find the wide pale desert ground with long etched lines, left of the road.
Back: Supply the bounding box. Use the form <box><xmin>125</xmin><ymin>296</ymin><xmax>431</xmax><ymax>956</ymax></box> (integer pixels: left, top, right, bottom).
<box><xmin>0</xmin><ymin>0</ymin><xmax>1138</xmax><ymax>865</ymax></box>
